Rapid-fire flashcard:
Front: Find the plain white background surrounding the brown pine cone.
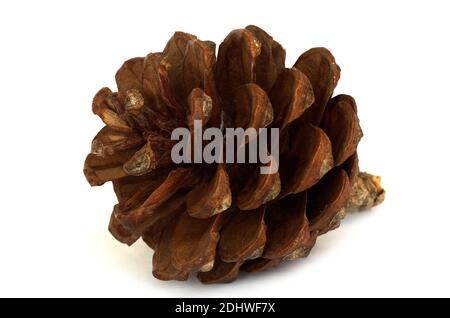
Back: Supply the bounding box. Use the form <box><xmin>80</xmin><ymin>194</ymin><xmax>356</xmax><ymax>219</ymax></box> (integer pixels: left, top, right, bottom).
<box><xmin>0</xmin><ymin>0</ymin><xmax>450</xmax><ymax>297</ymax></box>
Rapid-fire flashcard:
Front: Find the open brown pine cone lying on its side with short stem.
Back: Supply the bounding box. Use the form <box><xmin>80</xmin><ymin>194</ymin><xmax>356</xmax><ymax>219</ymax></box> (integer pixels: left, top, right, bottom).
<box><xmin>84</xmin><ymin>26</ymin><xmax>384</xmax><ymax>283</ymax></box>
